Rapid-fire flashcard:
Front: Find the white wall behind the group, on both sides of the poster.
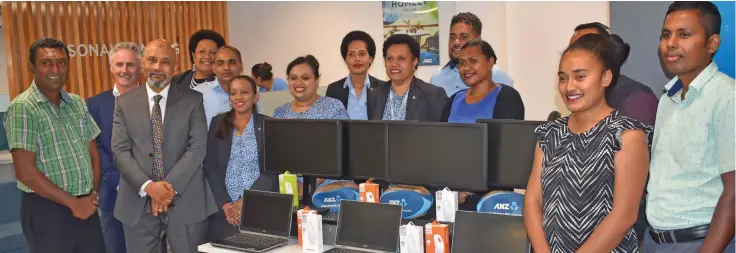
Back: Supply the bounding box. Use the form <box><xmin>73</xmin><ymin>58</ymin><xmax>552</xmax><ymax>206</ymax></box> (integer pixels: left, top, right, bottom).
<box><xmin>228</xmin><ymin>1</ymin><xmax>609</xmax><ymax>120</ymax></box>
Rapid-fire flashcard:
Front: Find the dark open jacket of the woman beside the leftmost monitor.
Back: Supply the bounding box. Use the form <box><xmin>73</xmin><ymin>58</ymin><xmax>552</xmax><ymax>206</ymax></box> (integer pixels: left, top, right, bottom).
<box><xmin>203</xmin><ymin>113</ymin><xmax>279</xmax><ymax>209</ymax></box>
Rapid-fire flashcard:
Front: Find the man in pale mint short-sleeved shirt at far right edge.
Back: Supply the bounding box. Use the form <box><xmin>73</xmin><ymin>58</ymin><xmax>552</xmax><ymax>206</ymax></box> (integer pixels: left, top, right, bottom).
<box><xmin>643</xmin><ymin>1</ymin><xmax>736</xmax><ymax>253</ymax></box>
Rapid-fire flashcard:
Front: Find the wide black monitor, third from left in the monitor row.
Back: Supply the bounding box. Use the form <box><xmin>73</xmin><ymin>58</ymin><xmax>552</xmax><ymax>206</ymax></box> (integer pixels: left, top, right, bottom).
<box><xmin>388</xmin><ymin>121</ymin><xmax>488</xmax><ymax>191</ymax></box>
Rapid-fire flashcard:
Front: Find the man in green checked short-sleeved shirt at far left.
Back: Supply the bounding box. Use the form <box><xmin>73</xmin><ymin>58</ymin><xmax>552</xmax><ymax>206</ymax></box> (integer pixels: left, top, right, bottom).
<box><xmin>3</xmin><ymin>38</ymin><xmax>105</xmax><ymax>253</ymax></box>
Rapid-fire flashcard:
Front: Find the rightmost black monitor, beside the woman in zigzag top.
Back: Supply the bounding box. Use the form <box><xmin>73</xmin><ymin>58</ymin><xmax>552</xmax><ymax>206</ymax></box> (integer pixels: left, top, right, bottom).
<box><xmin>478</xmin><ymin>119</ymin><xmax>546</xmax><ymax>189</ymax></box>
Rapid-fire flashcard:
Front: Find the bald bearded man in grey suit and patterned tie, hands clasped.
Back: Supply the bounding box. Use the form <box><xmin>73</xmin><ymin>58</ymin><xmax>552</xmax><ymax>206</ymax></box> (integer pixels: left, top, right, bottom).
<box><xmin>112</xmin><ymin>40</ymin><xmax>217</xmax><ymax>253</ymax></box>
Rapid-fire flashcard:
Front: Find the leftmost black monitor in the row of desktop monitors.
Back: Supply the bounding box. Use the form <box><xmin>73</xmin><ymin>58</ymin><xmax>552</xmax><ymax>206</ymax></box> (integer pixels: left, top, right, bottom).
<box><xmin>263</xmin><ymin>119</ymin><xmax>343</xmax><ymax>178</ymax></box>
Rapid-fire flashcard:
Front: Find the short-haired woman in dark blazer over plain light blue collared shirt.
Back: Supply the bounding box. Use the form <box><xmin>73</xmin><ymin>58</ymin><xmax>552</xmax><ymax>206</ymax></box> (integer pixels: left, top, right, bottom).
<box><xmin>326</xmin><ymin>31</ymin><xmax>383</xmax><ymax>120</ymax></box>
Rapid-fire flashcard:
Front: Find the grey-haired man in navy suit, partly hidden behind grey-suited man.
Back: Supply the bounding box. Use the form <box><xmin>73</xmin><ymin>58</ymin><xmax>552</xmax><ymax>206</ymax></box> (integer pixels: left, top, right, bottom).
<box><xmin>87</xmin><ymin>42</ymin><xmax>143</xmax><ymax>253</ymax></box>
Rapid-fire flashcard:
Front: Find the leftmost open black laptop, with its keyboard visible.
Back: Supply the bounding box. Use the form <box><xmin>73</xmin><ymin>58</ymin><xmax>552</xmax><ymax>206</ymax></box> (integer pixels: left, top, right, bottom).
<box><xmin>210</xmin><ymin>190</ymin><xmax>294</xmax><ymax>253</ymax></box>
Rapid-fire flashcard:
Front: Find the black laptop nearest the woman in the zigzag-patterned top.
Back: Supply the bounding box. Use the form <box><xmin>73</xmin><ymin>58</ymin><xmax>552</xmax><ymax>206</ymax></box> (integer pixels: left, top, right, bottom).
<box><xmin>452</xmin><ymin>211</ymin><xmax>531</xmax><ymax>253</ymax></box>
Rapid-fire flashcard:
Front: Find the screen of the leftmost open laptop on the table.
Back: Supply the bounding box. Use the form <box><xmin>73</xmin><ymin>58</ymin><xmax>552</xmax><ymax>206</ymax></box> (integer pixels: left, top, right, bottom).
<box><xmin>240</xmin><ymin>190</ymin><xmax>294</xmax><ymax>237</ymax></box>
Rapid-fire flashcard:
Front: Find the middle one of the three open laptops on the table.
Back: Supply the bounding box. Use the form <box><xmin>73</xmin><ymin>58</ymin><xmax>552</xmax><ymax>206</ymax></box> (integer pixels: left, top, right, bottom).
<box><xmin>325</xmin><ymin>200</ymin><xmax>401</xmax><ymax>253</ymax></box>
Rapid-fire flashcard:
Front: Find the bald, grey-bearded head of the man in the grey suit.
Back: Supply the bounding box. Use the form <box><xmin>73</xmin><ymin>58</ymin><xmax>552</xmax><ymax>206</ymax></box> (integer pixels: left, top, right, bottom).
<box><xmin>143</xmin><ymin>39</ymin><xmax>176</xmax><ymax>89</ymax></box>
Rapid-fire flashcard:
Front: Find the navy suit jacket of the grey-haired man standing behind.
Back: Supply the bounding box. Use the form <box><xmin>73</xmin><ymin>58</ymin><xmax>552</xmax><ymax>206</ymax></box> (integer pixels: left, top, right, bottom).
<box><xmin>87</xmin><ymin>90</ymin><xmax>120</xmax><ymax>211</ymax></box>
